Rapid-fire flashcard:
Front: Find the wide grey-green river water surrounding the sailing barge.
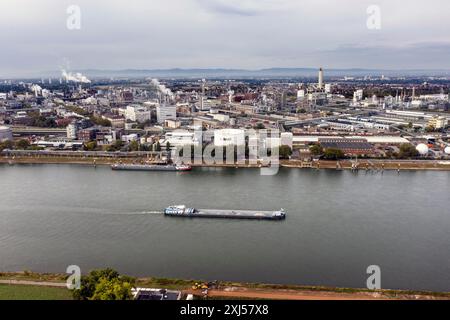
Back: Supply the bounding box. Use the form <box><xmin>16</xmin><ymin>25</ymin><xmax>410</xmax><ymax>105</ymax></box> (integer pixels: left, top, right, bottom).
<box><xmin>0</xmin><ymin>165</ymin><xmax>450</xmax><ymax>291</ymax></box>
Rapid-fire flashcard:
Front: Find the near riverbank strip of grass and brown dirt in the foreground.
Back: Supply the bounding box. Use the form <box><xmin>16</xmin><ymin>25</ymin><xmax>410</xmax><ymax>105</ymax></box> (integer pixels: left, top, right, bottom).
<box><xmin>0</xmin><ymin>271</ymin><xmax>450</xmax><ymax>300</ymax></box>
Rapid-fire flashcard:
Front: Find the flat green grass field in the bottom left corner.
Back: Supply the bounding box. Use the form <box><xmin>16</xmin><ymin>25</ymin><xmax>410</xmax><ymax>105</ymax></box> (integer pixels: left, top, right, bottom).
<box><xmin>0</xmin><ymin>284</ymin><xmax>72</xmax><ymax>300</ymax></box>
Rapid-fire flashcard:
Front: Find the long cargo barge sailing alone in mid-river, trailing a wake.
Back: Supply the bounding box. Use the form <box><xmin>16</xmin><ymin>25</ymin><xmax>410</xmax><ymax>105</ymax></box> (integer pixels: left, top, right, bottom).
<box><xmin>164</xmin><ymin>205</ymin><xmax>286</xmax><ymax>220</ymax></box>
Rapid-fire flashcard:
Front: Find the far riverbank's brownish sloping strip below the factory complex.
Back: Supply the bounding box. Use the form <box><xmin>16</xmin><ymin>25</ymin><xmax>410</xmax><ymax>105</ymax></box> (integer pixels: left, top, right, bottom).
<box><xmin>0</xmin><ymin>156</ymin><xmax>450</xmax><ymax>171</ymax></box>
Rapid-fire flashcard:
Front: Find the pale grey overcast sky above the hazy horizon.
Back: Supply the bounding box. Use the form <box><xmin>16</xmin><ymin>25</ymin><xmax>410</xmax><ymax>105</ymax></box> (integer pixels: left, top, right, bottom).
<box><xmin>0</xmin><ymin>0</ymin><xmax>450</xmax><ymax>77</ymax></box>
